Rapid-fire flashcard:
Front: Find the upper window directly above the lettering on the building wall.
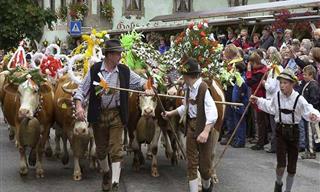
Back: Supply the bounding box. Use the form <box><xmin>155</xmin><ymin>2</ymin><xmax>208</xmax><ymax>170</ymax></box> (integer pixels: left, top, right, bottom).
<box><xmin>123</xmin><ymin>0</ymin><xmax>144</xmax><ymax>17</ymax></box>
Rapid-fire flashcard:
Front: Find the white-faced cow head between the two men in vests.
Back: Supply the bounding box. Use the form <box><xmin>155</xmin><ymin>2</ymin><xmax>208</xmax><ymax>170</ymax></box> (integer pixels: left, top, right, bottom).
<box><xmin>139</xmin><ymin>96</ymin><xmax>157</xmax><ymax>117</ymax></box>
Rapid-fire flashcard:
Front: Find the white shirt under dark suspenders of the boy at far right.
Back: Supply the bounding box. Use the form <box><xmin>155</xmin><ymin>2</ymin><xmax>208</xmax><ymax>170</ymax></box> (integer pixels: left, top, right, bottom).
<box><xmin>257</xmin><ymin>91</ymin><xmax>320</xmax><ymax>124</ymax></box>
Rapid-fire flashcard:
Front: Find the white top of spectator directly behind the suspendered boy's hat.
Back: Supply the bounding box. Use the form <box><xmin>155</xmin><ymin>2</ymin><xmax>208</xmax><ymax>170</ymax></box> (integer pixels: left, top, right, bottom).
<box><xmin>264</xmin><ymin>65</ymin><xmax>283</xmax><ymax>100</ymax></box>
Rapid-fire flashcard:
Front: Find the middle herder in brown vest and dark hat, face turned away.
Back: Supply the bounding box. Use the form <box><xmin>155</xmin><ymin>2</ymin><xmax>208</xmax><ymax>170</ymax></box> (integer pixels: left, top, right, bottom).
<box><xmin>162</xmin><ymin>58</ymin><xmax>218</xmax><ymax>192</ymax></box>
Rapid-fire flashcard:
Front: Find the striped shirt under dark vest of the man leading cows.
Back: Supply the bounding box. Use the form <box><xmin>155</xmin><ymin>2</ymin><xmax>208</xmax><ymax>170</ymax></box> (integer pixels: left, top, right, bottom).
<box><xmin>74</xmin><ymin>62</ymin><xmax>146</xmax><ymax>108</ymax></box>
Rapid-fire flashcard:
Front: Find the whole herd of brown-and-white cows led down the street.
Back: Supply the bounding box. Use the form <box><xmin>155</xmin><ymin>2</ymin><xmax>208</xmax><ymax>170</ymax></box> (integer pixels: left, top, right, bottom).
<box><xmin>0</xmin><ymin>47</ymin><xmax>225</xmax><ymax>184</ymax></box>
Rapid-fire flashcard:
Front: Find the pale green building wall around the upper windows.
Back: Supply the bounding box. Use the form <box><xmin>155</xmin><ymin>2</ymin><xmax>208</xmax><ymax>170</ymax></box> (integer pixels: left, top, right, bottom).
<box><xmin>42</xmin><ymin>0</ymin><xmax>269</xmax><ymax>42</ymax></box>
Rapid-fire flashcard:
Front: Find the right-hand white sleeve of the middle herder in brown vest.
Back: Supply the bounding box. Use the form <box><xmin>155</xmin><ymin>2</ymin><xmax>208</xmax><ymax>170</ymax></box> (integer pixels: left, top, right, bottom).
<box><xmin>204</xmin><ymin>90</ymin><xmax>218</xmax><ymax>125</ymax></box>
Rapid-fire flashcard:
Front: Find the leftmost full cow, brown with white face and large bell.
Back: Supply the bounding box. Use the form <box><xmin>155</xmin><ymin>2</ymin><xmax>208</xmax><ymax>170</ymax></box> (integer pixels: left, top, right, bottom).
<box><xmin>2</xmin><ymin>78</ymin><xmax>53</xmax><ymax>178</ymax></box>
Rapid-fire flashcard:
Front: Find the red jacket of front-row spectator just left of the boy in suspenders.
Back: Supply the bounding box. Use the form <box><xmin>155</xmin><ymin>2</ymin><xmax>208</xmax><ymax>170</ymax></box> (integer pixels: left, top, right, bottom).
<box><xmin>246</xmin><ymin>65</ymin><xmax>268</xmax><ymax>111</ymax></box>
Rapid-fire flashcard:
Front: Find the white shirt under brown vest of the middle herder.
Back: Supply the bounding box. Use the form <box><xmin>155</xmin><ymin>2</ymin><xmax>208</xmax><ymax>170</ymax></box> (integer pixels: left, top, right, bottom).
<box><xmin>177</xmin><ymin>78</ymin><xmax>218</xmax><ymax>125</ymax></box>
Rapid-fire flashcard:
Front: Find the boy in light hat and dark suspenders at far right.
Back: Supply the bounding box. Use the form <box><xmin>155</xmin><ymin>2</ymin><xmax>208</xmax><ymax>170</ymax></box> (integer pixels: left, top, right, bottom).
<box><xmin>250</xmin><ymin>68</ymin><xmax>320</xmax><ymax>192</ymax></box>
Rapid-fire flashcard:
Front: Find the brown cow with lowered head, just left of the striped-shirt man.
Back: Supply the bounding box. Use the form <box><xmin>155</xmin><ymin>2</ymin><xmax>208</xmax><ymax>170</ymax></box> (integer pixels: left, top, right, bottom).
<box><xmin>54</xmin><ymin>74</ymin><xmax>97</xmax><ymax>181</ymax></box>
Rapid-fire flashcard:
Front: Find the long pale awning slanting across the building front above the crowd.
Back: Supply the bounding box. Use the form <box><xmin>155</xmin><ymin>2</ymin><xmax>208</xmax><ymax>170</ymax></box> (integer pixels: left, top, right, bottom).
<box><xmin>150</xmin><ymin>0</ymin><xmax>320</xmax><ymax>22</ymax></box>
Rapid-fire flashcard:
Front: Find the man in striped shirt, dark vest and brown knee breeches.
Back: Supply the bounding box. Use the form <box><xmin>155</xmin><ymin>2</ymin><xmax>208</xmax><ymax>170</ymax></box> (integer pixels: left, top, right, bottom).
<box><xmin>74</xmin><ymin>39</ymin><xmax>152</xmax><ymax>191</ymax></box>
